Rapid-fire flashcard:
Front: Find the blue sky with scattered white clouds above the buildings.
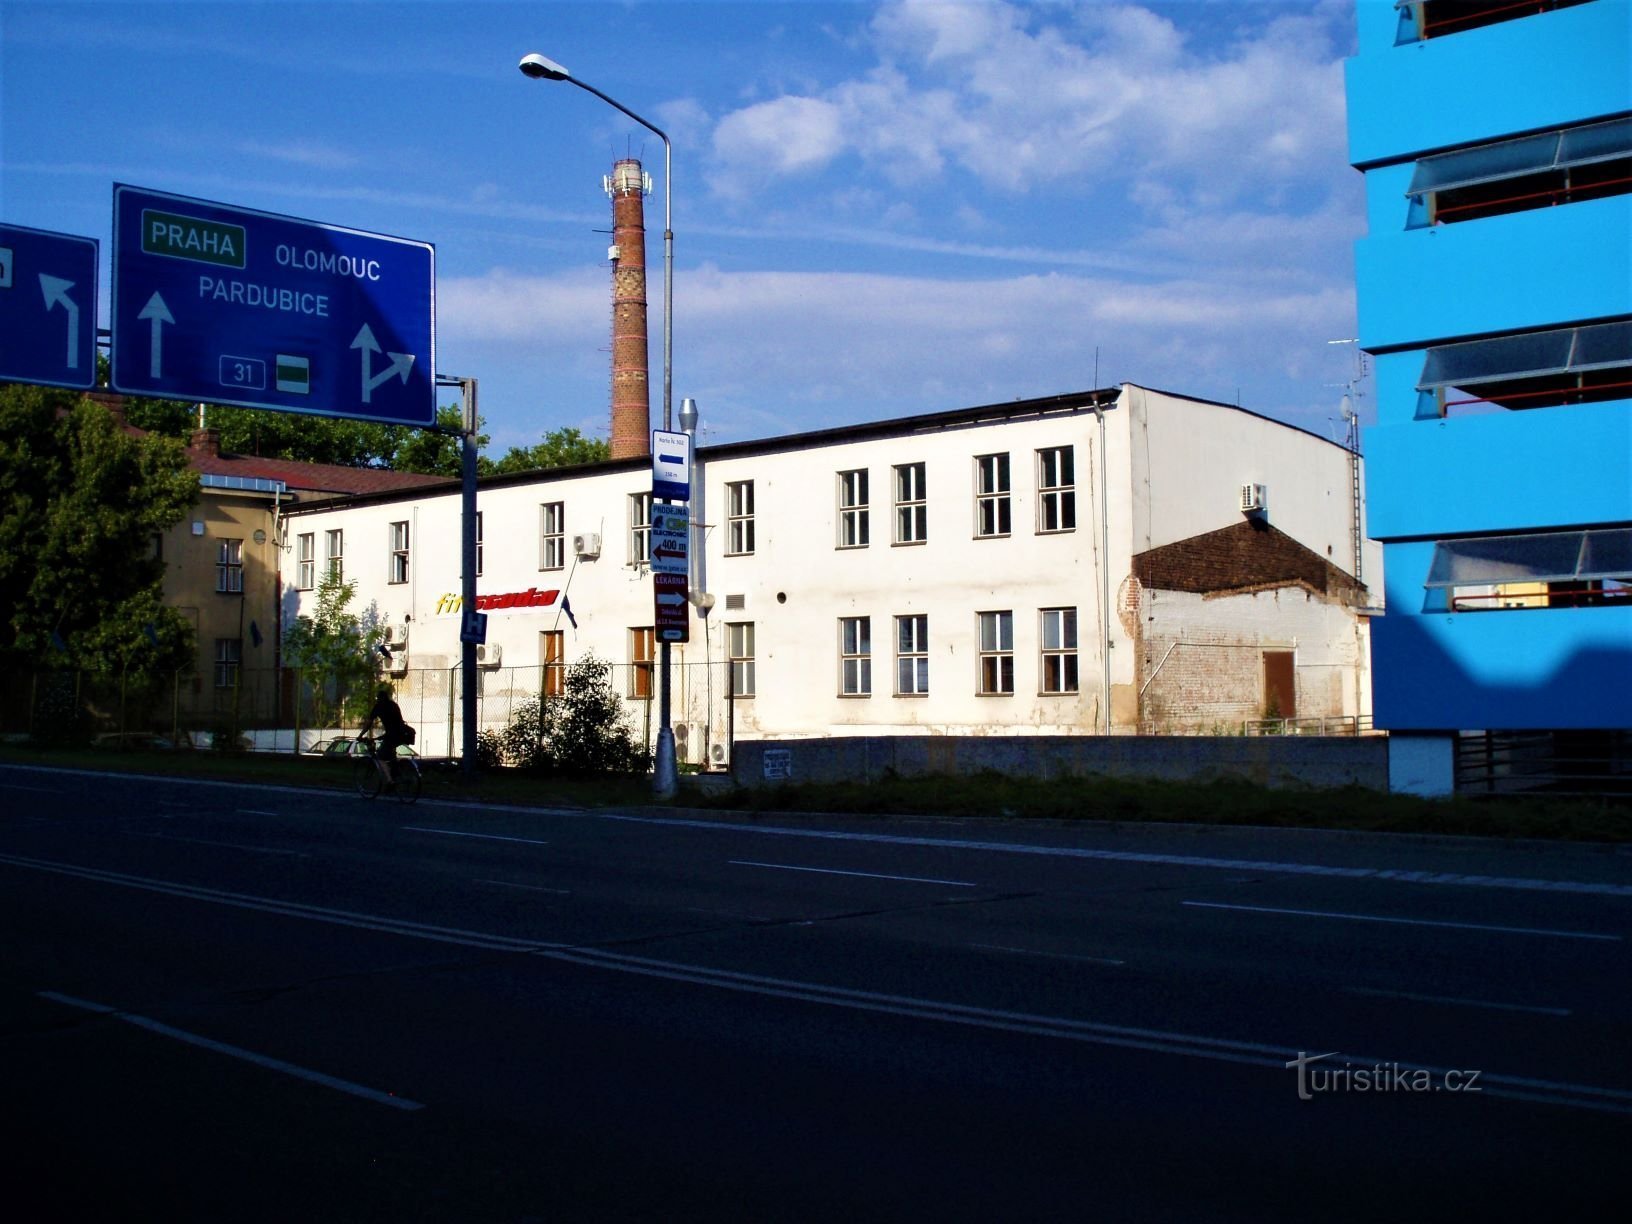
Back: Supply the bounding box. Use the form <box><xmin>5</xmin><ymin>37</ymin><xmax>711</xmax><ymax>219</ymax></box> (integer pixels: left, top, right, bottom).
<box><xmin>0</xmin><ymin>0</ymin><xmax>1387</xmax><ymax>450</ymax></box>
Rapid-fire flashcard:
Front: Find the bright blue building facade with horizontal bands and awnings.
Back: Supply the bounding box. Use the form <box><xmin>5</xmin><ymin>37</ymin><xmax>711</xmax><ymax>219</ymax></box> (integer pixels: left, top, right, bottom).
<box><xmin>1346</xmin><ymin>0</ymin><xmax>1632</xmax><ymax>793</ymax></box>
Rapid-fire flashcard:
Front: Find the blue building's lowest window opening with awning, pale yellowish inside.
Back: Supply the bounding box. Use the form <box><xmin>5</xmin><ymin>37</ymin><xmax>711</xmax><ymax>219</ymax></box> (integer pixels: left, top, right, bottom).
<box><xmin>1423</xmin><ymin>527</ymin><xmax>1632</xmax><ymax>612</ymax></box>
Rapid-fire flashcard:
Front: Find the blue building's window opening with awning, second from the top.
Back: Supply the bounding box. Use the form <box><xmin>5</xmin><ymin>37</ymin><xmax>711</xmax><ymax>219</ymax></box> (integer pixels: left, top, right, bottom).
<box><xmin>1405</xmin><ymin>119</ymin><xmax>1632</xmax><ymax>228</ymax></box>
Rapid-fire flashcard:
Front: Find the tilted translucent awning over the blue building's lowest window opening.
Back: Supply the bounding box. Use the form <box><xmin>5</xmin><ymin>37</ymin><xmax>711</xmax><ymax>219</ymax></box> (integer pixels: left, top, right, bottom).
<box><xmin>1423</xmin><ymin>527</ymin><xmax>1632</xmax><ymax>588</ymax></box>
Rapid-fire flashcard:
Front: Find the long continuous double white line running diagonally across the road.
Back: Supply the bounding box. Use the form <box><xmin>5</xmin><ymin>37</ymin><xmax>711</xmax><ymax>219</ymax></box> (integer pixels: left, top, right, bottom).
<box><xmin>0</xmin><ymin>854</ymin><xmax>1632</xmax><ymax>1116</ymax></box>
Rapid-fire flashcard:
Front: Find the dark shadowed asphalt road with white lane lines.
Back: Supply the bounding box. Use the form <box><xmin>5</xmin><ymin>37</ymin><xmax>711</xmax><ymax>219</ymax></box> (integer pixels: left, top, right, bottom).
<box><xmin>0</xmin><ymin>765</ymin><xmax>1632</xmax><ymax>1222</ymax></box>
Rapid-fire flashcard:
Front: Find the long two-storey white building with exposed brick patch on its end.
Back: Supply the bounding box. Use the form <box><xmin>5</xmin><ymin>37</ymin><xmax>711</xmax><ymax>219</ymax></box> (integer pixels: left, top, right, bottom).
<box><xmin>284</xmin><ymin>385</ymin><xmax>1381</xmax><ymax>764</ymax></box>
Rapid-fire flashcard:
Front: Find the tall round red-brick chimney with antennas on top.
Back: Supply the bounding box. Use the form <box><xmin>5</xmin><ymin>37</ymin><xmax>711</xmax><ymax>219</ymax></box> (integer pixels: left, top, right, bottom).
<box><xmin>605</xmin><ymin>158</ymin><xmax>651</xmax><ymax>459</ymax></box>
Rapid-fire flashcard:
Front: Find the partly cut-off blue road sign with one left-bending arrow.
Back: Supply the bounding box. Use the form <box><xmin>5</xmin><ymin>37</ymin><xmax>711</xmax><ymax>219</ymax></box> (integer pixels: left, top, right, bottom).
<box><xmin>0</xmin><ymin>225</ymin><xmax>96</xmax><ymax>388</ymax></box>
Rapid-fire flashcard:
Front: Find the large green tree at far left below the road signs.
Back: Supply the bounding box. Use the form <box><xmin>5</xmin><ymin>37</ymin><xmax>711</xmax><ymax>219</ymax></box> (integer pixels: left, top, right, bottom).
<box><xmin>0</xmin><ymin>385</ymin><xmax>199</xmax><ymax>676</ymax></box>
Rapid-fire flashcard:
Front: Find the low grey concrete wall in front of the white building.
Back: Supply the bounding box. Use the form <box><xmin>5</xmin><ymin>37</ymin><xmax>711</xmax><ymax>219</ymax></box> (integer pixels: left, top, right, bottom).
<box><xmin>733</xmin><ymin>736</ymin><xmax>1389</xmax><ymax>792</ymax></box>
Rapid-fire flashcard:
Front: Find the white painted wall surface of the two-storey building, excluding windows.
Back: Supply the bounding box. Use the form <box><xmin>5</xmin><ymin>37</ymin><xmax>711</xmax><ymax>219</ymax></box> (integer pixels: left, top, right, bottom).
<box><xmin>284</xmin><ymin>387</ymin><xmax>1377</xmax><ymax>752</ymax></box>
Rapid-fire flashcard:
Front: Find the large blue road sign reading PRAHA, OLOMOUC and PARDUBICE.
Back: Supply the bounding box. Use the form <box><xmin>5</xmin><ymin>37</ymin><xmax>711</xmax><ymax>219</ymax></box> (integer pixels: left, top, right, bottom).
<box><xmin>113</xmin><ymin>184</ymin><xmax>436</xmax><ymax>426</ymax></box>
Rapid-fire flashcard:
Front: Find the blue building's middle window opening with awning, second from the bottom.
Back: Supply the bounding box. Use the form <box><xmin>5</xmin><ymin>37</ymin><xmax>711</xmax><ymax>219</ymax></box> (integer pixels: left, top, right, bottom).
<box><xmin>1417</xmin><ymin>320</ymin><xmax>1632</xmax><ymax>418</ymax></box>
